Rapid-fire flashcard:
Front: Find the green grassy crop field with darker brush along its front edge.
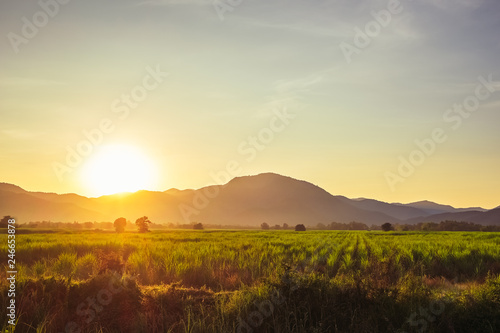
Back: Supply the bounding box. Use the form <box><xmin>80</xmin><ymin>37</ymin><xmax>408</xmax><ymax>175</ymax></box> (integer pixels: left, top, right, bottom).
<box><xmin>0</xmin><ymin>231</ymin><xmax>500</xmax><ymax>333</ymax></box>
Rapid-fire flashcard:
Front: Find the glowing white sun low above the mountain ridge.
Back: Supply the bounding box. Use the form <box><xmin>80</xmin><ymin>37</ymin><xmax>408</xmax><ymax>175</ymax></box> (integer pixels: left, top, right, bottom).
<box><xmin>82</xmin><ymin>145</ymin><xmax>157</xmax><ymax>196</ymax></box>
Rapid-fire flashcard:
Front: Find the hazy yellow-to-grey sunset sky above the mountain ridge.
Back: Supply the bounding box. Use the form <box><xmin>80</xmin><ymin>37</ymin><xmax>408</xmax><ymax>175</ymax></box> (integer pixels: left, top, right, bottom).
<box><xmin>0</xmin><ymin>0</ymin><xmax>500</xmax><ymax>208</ymax></box>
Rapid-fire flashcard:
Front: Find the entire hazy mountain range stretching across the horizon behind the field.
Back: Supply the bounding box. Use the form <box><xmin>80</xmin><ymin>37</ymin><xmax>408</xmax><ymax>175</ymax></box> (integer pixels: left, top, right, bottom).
<box><xmin>0</xmin><ymin>173</ymin><xmax>500</xmax><ymax>226</ymax></box>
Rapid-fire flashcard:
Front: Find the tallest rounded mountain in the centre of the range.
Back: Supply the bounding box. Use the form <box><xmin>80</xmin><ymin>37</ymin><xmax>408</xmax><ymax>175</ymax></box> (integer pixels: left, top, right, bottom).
<box><xmin>186</xmin><ymin>173</ymin><xmax>398</xmax><ymax>225</ymax></box>
